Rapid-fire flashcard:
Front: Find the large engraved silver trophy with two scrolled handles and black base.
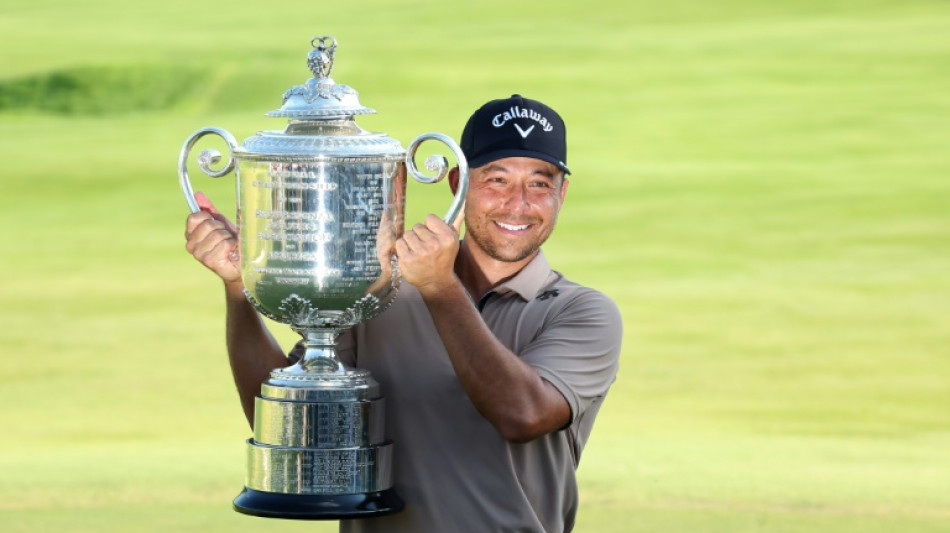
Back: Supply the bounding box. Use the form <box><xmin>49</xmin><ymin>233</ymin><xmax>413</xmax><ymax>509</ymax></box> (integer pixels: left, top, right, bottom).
<box><xmin>178</xmin><ymin>37</ymin><xmax>468</xmax><ymax>519</ymax></box>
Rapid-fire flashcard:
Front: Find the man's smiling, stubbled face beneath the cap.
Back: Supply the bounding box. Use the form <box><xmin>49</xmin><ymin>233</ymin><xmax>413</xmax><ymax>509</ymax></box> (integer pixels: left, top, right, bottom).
<box><xmin>465</xmin><ymin>157</ymin><xmax>568</xmax><ymax>262</ymax></box>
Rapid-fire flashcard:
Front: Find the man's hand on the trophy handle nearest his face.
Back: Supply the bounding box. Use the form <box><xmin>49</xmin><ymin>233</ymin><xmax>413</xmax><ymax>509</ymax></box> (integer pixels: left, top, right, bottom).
<box><xmin>396</xmin><ymin>211</ymin><xmax>463</xmax><ymax>295</ymax></box>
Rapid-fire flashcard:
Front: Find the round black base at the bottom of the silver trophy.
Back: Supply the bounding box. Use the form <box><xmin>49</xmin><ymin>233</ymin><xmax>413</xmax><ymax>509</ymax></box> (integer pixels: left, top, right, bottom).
<box><xmin>234</xmin><ymin>487</ymin><xmax>405</xmax><ymax>520</ymax></box>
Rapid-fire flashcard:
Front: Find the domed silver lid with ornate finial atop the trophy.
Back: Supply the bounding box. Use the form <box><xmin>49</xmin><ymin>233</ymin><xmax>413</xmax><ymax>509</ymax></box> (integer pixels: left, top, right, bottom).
<box><xmin>235</xmin><ymin>36</ymin><xmax>406</xmax><ymax>161</ymax></box>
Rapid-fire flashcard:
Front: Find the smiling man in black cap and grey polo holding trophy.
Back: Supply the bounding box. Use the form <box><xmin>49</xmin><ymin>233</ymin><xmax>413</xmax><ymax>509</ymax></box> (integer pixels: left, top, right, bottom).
<box><xmin>186</xmin><ymin>95</ymin><xmax>622</xmax><ymax>532</ymax></box>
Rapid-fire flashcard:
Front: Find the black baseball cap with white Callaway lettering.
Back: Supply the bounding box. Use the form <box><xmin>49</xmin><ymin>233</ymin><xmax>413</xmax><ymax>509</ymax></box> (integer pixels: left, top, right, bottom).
<box><xmin>461</xmin><ymin>94</ymin><xmax>571</xmax><ymax>174</ymax></box>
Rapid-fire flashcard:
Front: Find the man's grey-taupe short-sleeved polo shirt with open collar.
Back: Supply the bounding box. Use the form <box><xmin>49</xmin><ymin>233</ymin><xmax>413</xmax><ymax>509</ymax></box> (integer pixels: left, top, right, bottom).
<box><xmin>338</xmin><ymin>250</ymin><xmax>622</xmax><ymax>533</ymax></box>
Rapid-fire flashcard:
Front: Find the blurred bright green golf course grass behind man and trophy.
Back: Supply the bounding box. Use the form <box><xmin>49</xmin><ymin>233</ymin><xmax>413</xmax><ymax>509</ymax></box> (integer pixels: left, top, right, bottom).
<box><xmin>0</xmin><ymin>0</ymin><xmax>950</xmax><ymax>533</ymax></box>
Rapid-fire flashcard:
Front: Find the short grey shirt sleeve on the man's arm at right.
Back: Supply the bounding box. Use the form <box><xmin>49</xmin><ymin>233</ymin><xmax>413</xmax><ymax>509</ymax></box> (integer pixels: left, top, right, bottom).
<box><xmin>519</xmin><ymin>289</ymin><xmax>623</xmax><ymax>423</ymax></box>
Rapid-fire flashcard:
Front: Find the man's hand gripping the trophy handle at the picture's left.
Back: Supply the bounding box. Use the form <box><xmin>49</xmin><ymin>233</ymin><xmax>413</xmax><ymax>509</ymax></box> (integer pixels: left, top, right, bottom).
<box><xmin>185</xmin><ymin>192</ymin><xmax>241</xmax><ymax>285</ymax></box>
